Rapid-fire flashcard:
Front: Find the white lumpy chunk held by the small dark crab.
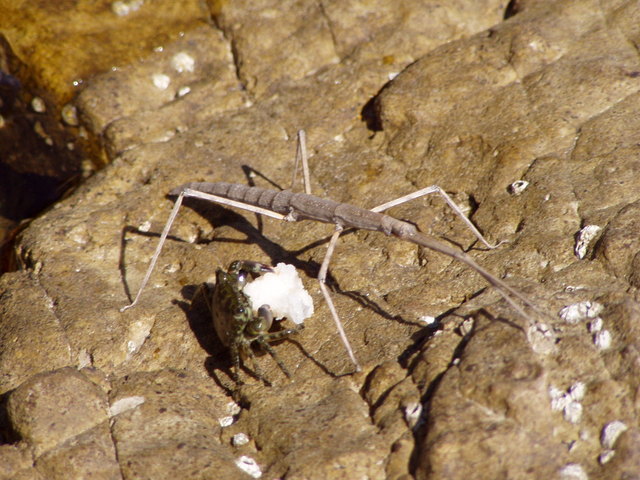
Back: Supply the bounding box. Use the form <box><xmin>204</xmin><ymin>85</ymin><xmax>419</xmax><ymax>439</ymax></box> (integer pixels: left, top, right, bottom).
<box><xmin>243</xmin><ymin>263</ymin><xmax>313</xmax><ymax>324</ymax></box>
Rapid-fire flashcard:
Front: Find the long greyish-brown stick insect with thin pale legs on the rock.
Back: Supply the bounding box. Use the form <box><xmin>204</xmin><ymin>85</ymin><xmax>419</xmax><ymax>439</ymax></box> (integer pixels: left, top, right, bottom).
<box><xmin>121</xmin><ymin>130</ymin><xmax>537</xmax><ymax>371</ymax></box>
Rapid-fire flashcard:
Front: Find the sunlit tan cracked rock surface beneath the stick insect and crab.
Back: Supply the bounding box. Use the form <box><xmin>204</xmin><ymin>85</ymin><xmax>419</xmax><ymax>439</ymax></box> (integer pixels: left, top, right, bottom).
<box><xmin>0</xmin><ymin>1</ymin><xmax>640</xmax><ymax>480</ymax></box>
